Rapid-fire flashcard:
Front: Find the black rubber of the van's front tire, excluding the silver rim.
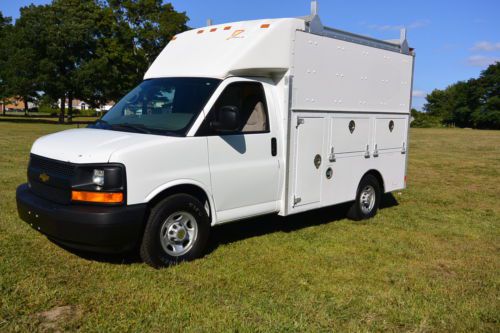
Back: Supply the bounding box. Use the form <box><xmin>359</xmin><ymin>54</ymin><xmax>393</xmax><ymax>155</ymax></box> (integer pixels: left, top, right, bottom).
<box><xmin>141</xmin><ymin>194</ymin><xmax>210</xmax><ymax>267</ymax></box>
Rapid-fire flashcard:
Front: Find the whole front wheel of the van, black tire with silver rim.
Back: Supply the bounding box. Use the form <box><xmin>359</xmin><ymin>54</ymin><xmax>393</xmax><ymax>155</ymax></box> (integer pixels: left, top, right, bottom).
<box><xmin>140</xmin><ymin>194</ymin><xmax>210</xmax><ymax>268</ymax></box>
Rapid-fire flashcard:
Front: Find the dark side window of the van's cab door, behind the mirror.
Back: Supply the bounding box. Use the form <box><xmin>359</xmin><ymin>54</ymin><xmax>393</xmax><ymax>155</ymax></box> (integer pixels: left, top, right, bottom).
<box><xmin>197</xmin><ymin>82</ymin><xmax>269</xmax><ymax>136</ymax></box>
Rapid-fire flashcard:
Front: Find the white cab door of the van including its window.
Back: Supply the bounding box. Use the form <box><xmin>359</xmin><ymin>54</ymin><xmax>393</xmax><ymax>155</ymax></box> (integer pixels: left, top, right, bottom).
<box><xmin>197</xmin><ymin>80</ymin><xmax>279</xmax><ymax>223</ymax></box>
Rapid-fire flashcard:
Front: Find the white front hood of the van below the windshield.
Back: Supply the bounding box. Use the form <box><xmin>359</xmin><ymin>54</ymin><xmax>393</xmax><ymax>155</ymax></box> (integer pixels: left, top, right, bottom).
<box><xmin>31</xmin><ymin>128</ymin><xmax>173</xmax><ymax>163</ymax></box>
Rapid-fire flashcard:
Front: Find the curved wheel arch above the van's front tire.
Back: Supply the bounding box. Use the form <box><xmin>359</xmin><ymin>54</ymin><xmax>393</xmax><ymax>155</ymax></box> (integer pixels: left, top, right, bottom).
<box><xmin>146</xmin><ymin>180</ymin><xmax>217</xmax><ymax>225</ymax></box>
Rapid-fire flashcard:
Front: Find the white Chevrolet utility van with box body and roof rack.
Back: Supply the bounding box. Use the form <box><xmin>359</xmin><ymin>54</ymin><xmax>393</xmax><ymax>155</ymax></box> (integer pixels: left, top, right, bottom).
<box><xmin>17</xmin><ymin>2</ymin><xmax>414</xmax><ymax>267</ymax></box>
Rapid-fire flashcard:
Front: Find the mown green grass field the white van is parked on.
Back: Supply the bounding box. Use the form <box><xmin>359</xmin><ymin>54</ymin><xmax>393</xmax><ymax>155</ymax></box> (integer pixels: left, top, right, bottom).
<box><xmin>0</xmin><ymin>123</ymin><xmax>500</xmax><ymax>332</ymax></box>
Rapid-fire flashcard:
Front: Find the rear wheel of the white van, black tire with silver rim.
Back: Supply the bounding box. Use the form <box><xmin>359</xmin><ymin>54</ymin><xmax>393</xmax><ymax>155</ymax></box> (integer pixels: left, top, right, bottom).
<box><xmin>347</xmin><ymin>175</ymin><xmax>382</xmax><ymax>221</ymax></box>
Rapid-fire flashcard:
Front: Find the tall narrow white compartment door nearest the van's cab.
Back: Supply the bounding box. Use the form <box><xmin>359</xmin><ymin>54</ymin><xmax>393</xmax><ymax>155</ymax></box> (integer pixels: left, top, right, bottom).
<box><xmin>293</xmin><ymin>116</ymin><xmax>325</xmax><ymax>207</ymax></box>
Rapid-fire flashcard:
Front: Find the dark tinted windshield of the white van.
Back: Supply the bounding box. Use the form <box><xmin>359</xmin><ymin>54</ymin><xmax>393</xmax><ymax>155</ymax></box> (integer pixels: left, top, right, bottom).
<box><xmin>90</xmin><ymin>78</ymin><xmax>220</xmax><ymax>136</ymax></box>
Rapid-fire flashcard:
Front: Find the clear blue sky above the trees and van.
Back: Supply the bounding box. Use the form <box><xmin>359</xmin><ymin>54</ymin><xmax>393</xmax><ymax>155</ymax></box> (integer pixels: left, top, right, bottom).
<box><xmin>0</xmin><ymin>0</ymin><xmax>500</xmax><ymax>108</ymax></box>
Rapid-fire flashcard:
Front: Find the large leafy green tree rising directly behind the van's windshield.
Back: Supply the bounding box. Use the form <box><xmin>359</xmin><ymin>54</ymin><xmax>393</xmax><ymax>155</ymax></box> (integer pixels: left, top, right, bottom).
<box><xmin>41</xmin><ymin>0</ymin><xmax>188</xmax><ymax>122</ymax></box>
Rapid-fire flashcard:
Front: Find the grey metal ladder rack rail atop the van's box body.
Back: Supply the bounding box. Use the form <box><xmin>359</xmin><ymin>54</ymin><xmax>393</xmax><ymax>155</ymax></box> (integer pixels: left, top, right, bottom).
<box><xmin>301</xmin><ymin>0</ymin><xmax>410</xmax><ymax>54</ymax></box>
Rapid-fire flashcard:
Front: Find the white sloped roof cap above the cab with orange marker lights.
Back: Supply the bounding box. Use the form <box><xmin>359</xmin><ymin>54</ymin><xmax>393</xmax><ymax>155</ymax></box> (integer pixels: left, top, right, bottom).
<box><xmin>144</xmin><ymin>19</ymin><xmax>305</xmax><ymax>79</ymax></box>
